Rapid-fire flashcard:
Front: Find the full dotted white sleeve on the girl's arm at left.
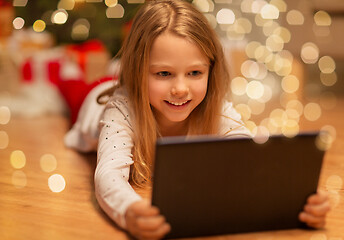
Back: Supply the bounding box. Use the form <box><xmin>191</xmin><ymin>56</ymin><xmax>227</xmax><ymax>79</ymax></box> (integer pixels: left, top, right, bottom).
<box><xmin>94</xmin><ymin>89</ymin><xmax>141</xmax><ymax>228</ymax></box>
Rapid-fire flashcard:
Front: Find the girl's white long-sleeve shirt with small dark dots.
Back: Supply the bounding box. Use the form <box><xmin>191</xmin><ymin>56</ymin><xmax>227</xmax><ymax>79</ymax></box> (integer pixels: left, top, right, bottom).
<box><xmin>65</xmin><ymin>83</ymin><xmax>250</xmax><ymax>228</ymax></box>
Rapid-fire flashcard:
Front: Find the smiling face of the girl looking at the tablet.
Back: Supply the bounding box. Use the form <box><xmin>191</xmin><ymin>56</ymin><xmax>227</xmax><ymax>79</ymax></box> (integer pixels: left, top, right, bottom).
<box><xmin>148</xmin><ymin>33</ymin><xmax>209</xmax><ymax>130</ymax></box>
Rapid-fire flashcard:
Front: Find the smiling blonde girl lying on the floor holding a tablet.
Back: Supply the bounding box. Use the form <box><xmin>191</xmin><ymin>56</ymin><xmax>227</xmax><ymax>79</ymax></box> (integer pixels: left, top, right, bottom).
<box><xmin>64</xmin><ymin>0</ymin><xmax>329</xmax><ymax>239</ymax></box>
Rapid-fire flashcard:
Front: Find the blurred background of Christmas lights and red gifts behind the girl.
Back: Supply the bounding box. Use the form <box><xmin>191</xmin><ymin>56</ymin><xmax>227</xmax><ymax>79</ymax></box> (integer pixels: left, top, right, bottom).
<box><xmin>0</xmin><ymin>0</ymin><xmax>344</xmax><ymax>137</ymax></box>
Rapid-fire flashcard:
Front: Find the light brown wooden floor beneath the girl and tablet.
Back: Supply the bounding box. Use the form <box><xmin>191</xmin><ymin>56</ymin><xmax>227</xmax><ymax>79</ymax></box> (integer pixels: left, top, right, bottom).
<box><xmin>0</xmin><ymin>99</ymin><xmax>344</xmax><ymax>240</ymax></box>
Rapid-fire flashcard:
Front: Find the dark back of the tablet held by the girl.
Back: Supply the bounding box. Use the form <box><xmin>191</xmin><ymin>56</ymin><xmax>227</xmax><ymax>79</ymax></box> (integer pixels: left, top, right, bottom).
<box><xmin>152</xmin><ymin>133</ymin><xmax>324</xmax><ymax>238</ymax></box>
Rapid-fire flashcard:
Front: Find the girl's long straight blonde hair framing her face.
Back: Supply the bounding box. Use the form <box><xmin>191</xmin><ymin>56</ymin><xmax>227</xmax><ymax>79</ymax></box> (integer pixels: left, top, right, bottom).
<box><xmin>103</xmin><ymin>0</ymin><xmax>229</xmax><ymax>187</ymax></box>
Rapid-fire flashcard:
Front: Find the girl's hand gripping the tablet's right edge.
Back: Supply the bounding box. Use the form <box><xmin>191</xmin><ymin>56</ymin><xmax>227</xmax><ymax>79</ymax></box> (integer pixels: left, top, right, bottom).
<box><xmin>299</xmin><ymin>191</ymin><xmax>330</xmax><ymax>228</ymax></box>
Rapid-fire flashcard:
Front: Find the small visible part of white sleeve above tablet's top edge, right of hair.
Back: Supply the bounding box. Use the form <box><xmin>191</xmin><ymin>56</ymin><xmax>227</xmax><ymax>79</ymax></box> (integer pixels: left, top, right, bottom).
<box><xmin>219</xmin><ymin>101</ymin><xmax>252</xmax><ymax>138</ymax></box>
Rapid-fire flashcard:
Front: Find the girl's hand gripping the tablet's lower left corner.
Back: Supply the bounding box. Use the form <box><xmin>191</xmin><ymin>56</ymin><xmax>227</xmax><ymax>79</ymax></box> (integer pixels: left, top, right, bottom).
<box><xmin>125</xmin><ymin>200</ymin><xmax>171</xmax><ymax>240</ymax></box>
